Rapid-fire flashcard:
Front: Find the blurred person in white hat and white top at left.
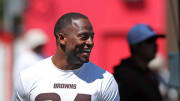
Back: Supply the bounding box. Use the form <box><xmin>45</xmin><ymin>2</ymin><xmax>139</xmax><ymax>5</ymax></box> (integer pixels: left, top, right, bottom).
<box><xmin>13</xmin><ymin>29</ymin><xmax>48</xmax><ymax>99</ymax></box>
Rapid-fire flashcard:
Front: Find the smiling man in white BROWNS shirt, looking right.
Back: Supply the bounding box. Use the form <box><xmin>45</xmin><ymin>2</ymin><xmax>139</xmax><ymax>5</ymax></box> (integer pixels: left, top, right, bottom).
<box><xmin>12</xmin><ymin>13</ymin><xmax>119</xmax><ymax>101</ymax></box>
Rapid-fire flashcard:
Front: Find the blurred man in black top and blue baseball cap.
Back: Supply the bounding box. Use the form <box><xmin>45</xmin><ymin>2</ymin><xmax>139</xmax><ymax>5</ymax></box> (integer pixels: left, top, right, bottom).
<box><xmin>114</xmin><ymin>24</ymin><xmax>164</xmax><ymax>101</ymax></box>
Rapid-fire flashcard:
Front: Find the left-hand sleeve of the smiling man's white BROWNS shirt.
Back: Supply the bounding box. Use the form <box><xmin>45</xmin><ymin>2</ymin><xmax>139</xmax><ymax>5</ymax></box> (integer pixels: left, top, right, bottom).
<box><xmin>12</xmin><ymin>73</ymin><xmax>28</xmax><ymax>101</ymax></box>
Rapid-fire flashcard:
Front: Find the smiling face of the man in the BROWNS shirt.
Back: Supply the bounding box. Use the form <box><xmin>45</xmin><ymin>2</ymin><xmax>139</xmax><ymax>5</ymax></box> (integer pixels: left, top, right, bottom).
<box><xmin>65</xmin><ymin>18</ymin><xmax>94</xmax><ymax>64</ymax></box>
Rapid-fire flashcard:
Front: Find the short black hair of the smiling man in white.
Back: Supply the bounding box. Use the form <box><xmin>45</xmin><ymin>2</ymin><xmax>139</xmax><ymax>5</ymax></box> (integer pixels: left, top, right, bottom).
<box><xmin>54</xmin><ymin>12</ymin><xmax>88</xmax><ymax>42</ymax></box>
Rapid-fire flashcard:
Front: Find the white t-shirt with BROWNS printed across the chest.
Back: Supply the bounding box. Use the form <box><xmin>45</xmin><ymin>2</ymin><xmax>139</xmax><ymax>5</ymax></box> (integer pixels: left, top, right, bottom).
<box><xmin>13</xmin><ymin>57</ymin><xmax>120</xmax><ymax>101</ymax></box>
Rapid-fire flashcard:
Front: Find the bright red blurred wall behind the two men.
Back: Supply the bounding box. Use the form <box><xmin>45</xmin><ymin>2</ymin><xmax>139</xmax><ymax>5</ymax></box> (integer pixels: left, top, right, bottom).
<box><xmin>24</xmin><ymin>0</ymin><xmax>166</xmax><ymax>72</ymax></box>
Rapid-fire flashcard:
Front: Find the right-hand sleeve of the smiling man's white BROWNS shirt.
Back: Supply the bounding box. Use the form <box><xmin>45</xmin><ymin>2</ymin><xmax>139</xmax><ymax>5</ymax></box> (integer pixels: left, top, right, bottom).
<box><xmin>102</xmin><ymin>76</ymin><xmax>120</xmax><ymax>101</ymax></box>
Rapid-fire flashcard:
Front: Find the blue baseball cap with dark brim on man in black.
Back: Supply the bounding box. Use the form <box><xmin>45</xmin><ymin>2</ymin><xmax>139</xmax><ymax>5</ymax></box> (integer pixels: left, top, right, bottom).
<box><xmin>127</xmin><ymin>24</ymin><xmax>165</xmax><ymax>45</ymax></box>
